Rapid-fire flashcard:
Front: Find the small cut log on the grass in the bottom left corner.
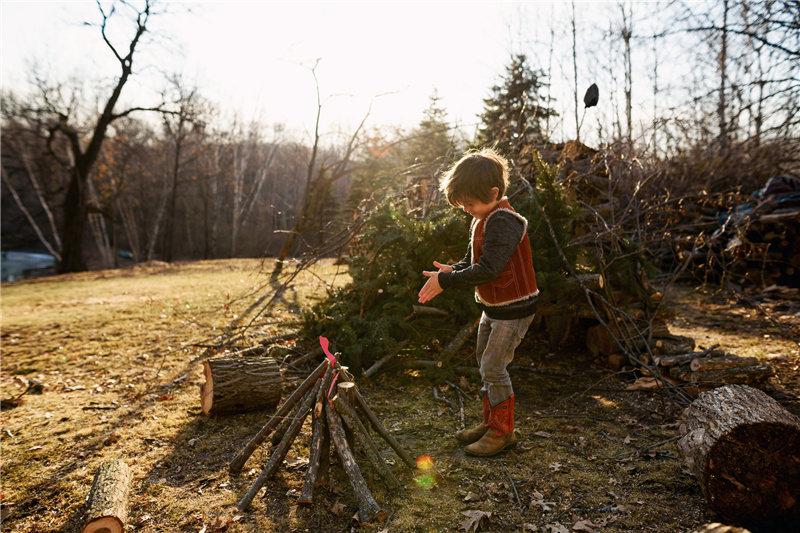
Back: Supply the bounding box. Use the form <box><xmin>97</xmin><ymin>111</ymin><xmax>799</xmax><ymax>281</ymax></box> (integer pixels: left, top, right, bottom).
<box><xmin>81</xmin><ymin>459</ymin><xmax>133</xmax><ymax>533</ymax></box>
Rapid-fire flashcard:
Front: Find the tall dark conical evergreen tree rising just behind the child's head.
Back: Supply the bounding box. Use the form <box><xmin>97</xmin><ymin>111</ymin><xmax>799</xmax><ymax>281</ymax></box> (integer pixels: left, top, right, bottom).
<box><xmin>475</xmin><ymin>54</ymin><xmax>557</xmax><ymax>157</ymax></box>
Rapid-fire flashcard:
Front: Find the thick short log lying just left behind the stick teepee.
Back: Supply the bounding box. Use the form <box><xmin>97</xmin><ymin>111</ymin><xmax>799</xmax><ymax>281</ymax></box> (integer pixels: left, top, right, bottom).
<box><xmin>200</xmin><ymin>357</ymin><xmax>283</xmax><ymax>416</ymax></box>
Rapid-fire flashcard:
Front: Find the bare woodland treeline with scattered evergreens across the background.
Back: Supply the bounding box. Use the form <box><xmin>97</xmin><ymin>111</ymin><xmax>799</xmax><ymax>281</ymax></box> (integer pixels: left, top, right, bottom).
<box><xmin>0</xmin><ymin>0</ymin><xmax>800</xmax><ymax>272</ymax></box>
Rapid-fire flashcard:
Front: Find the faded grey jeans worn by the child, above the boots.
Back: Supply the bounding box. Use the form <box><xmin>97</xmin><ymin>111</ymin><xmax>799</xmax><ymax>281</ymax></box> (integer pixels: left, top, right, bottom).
<box><xmin>475</xmin><ymin>313</ymin><xmax>534</xmax><ymax>407</ymax></box>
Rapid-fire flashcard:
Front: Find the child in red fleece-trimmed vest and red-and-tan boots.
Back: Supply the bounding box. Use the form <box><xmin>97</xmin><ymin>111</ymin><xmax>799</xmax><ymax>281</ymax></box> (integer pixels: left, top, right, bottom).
<box><xmin>419</xmin><ymin>149</ymin><xmax>539</xmax><ymax>457</ymax></box>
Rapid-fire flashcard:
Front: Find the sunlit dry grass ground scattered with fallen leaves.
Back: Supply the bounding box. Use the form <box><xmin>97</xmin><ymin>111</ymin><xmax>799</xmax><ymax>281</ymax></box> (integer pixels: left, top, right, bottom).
<box><xmin>0</xmin><ymin>260</ymin><xmax>800</xmax><ymax>533</ymax></box>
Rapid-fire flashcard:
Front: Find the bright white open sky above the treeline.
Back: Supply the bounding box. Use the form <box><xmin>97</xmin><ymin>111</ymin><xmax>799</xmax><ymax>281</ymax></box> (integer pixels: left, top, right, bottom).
<box><xmin>1</xmin><ymin>0</ymin><xmax>551</xmax><ymax>139</ymax></box>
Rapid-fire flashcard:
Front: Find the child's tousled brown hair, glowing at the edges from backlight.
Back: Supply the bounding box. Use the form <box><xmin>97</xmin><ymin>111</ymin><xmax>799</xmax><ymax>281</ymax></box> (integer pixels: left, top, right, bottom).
<box><xmin>439</xmin><ymin>148</ymin><xmax>508</xmax><ymax>207</ymax></box>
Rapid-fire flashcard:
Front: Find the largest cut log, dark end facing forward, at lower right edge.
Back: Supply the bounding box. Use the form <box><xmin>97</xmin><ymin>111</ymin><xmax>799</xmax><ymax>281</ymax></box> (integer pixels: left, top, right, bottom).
<box><xmin>678</xmin><ymin>385</ymin><xmax>800</xmax><ymax>532</ymax></box>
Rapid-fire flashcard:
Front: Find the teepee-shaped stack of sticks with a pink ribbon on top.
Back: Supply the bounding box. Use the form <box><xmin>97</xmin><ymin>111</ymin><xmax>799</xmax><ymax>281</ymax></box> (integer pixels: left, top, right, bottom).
<box><xmin>230</xmin><ymin>350</ymin><xmax>414</xmax><ymax>525</ymax></box>
